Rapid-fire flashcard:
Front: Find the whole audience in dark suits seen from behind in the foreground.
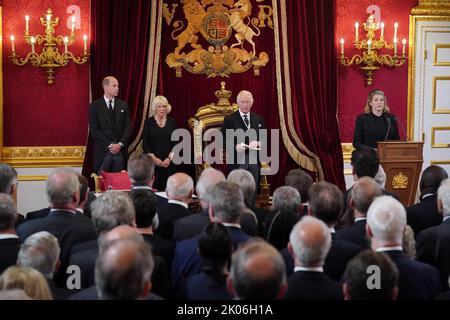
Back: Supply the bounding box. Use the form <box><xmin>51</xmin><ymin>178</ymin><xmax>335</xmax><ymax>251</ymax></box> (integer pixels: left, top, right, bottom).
<box><xmin>0</xmin><ymin>160</ymin><xmax>450</xmax><ymax>300</ymax></box>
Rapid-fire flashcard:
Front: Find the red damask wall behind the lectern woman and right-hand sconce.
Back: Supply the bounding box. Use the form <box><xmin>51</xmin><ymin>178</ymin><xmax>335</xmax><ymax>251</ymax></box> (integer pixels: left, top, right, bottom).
<box><xmin>336</xmin><ymin>0</ymin><xmax>418</xmax><ymax>142</ymax></box>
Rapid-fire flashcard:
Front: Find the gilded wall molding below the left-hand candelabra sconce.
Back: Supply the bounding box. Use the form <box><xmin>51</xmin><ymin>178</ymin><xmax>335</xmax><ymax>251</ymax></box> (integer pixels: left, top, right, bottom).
<box><xmin>2</xmin><ymin>146</ymin><xmax>86</xmax><ymax>168</ymax></box>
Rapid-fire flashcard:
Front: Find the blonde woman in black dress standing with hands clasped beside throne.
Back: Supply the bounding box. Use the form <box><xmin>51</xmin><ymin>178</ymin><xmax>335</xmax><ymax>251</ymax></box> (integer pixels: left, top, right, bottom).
<box><xmin>143</xmin><ymin>96</ymin><xmax>177</xmax><ymax>191</ymax></box>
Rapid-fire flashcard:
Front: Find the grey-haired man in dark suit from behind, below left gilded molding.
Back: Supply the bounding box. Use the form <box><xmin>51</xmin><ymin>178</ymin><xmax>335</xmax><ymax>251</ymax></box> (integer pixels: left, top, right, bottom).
<box><xmin>17</xmin><ymin>168</ymin><xmax>97</xmax><ymax>286</ymax></box>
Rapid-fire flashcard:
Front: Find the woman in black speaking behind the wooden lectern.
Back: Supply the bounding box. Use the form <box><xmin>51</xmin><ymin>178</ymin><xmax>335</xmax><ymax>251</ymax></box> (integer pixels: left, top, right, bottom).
<box><xmin>353</xmin><ymin>90</ymin><xmax>400</xmax><ymax>149</ymax></box>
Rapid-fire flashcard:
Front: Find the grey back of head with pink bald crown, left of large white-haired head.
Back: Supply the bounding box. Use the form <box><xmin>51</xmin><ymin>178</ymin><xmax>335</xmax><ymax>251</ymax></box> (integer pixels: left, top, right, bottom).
<box><xmin>289</xmin><ymin>216</ymin><xmax>331</xmax><ymax>267</ymax></box>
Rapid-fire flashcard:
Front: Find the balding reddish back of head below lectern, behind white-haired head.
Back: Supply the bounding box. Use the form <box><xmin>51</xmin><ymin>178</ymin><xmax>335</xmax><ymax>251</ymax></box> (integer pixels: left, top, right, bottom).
<box><xmin>351</xmin><ymin>177</ymin><xmax>382</xmax><ymax>214</ymax></box>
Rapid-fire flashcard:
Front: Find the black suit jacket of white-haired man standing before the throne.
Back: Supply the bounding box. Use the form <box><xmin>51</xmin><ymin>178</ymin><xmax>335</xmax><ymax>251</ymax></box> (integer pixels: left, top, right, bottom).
<box><xmin>221</xmin><ymin>110</ymin><xmax>266</xmax><ymax>172</ymax></box>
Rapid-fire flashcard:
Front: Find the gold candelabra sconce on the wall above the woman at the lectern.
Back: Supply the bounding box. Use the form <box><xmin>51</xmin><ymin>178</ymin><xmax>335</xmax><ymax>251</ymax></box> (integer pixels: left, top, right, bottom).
<box><xmin>339</xmin><ymin>15</ymin><xmax>406</xmax><ymax>86</ymax></box>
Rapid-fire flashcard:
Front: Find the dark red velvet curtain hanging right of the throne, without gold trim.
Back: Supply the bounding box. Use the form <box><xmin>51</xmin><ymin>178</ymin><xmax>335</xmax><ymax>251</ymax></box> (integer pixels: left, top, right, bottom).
<box><xmin>280</xmin><ymin>0</ymin><xmax>345</xmax><ymax>189</ymax></box>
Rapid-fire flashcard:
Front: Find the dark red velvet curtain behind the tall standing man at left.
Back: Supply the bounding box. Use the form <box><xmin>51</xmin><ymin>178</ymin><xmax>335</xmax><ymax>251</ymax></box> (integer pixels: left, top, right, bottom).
<box><xmin>83</xmin><ymin>0</ymin><xmax>151</xmax><ymax>177</ymax></box>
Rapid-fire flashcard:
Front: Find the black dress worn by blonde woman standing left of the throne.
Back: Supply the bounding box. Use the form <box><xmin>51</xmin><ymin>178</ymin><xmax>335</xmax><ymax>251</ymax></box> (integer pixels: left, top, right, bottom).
<box><xmin>142</xmin><ymin>117</ymin><xmax>177</xmax><ymax>191</ymax></box>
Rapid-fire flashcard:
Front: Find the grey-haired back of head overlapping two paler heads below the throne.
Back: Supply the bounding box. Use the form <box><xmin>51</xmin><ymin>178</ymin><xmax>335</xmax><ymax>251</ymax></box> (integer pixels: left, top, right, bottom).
<box><xmin>210</xmin><ymin>181</ymin><xmax>245</xmax><ymax>223</ymax></box>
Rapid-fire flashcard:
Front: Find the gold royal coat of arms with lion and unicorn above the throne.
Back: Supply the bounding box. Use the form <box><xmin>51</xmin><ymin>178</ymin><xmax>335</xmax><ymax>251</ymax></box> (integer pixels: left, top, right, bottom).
<box><xmin>163</xmin><ymin>0</ymin><xmax>273</xmax><ymax>77</ymax></box>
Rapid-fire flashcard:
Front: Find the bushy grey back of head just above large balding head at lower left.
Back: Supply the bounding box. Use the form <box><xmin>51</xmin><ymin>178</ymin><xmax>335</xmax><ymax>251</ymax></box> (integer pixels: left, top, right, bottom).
<box><xmin>91</xmin><ymin>191</ymin><xmax>136</xmax><ymax>234</ymax></box>
